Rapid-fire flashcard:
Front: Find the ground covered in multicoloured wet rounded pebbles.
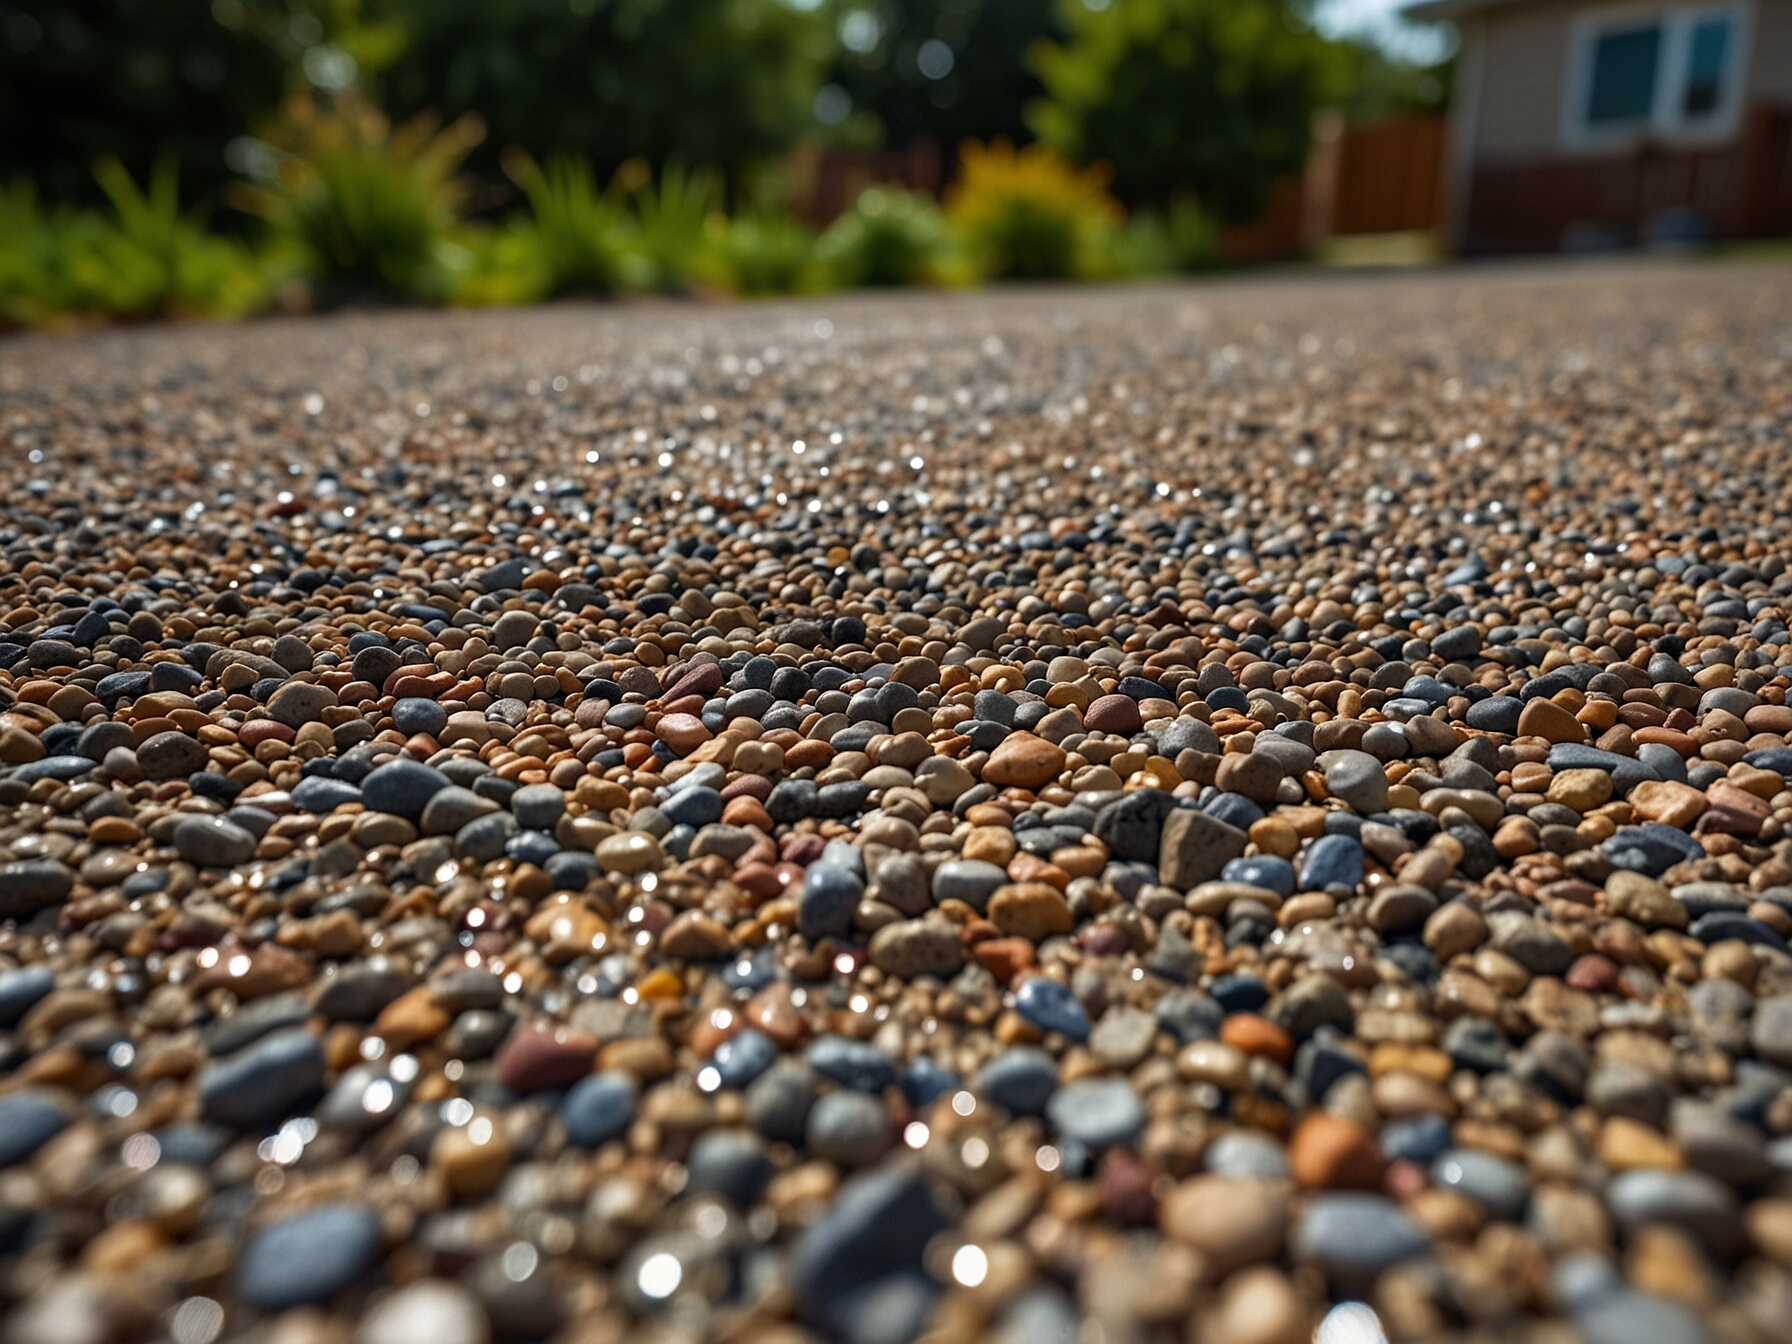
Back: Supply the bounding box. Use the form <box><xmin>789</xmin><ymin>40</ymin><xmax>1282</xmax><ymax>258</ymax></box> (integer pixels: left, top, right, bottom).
<box><xmin>0</xmin><ymin>265</ymin><xmax>1792</xmax><ymax>1344</ymax></box>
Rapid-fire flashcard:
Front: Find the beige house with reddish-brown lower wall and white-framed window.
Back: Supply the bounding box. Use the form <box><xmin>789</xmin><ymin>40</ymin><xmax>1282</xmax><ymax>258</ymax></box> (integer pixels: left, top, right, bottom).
<box><xmin>1405</xmin><ymin>0</ymin><xmax>1792</xmax><ymax>254</ymax></box>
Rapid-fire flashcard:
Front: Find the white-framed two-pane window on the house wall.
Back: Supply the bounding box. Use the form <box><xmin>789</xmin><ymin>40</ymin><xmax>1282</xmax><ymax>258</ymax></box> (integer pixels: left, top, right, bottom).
<box><xmin>1563</xmin><ymin>0</ymin><xmax>1747</xmax><ymax>145</ymax></box>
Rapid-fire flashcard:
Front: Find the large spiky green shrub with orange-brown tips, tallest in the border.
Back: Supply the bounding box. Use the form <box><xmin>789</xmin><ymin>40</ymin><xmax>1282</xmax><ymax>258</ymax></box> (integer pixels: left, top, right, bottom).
<box><xmin>238</xmin><ymin>99</ymin><xmax>482</xmax><ymax>303</ymax></box>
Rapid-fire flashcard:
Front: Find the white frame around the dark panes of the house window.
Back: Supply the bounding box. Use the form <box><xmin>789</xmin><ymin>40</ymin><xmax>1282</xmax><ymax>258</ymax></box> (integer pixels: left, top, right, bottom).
<box><xmin>1561</xmin><ymin>0</ymin><xmax>1754</xmax><ymax>149</ymax></box>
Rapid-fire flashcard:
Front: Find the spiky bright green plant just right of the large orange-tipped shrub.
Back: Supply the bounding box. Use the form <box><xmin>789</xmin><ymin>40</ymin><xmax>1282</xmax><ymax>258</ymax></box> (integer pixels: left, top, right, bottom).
<box><xmin>504</xmin><ymin>151</ymin><xmax>642</xmax><ymax>294</ymax></box>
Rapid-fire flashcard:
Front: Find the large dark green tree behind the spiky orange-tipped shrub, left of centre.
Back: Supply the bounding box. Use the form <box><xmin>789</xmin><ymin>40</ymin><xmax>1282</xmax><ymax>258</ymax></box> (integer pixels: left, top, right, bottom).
<box><xmin>373</xmin><ymin>0</ymin><xmax>833</xmax><ymax>199</ymax></box>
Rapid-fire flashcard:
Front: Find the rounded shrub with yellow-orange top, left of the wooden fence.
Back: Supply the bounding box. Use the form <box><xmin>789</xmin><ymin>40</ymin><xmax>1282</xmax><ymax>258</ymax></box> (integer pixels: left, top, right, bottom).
<box><xmin>946</xmin><ymin>140</ymin><xmax>1122</xmax><ymax>280</ymax></box>
